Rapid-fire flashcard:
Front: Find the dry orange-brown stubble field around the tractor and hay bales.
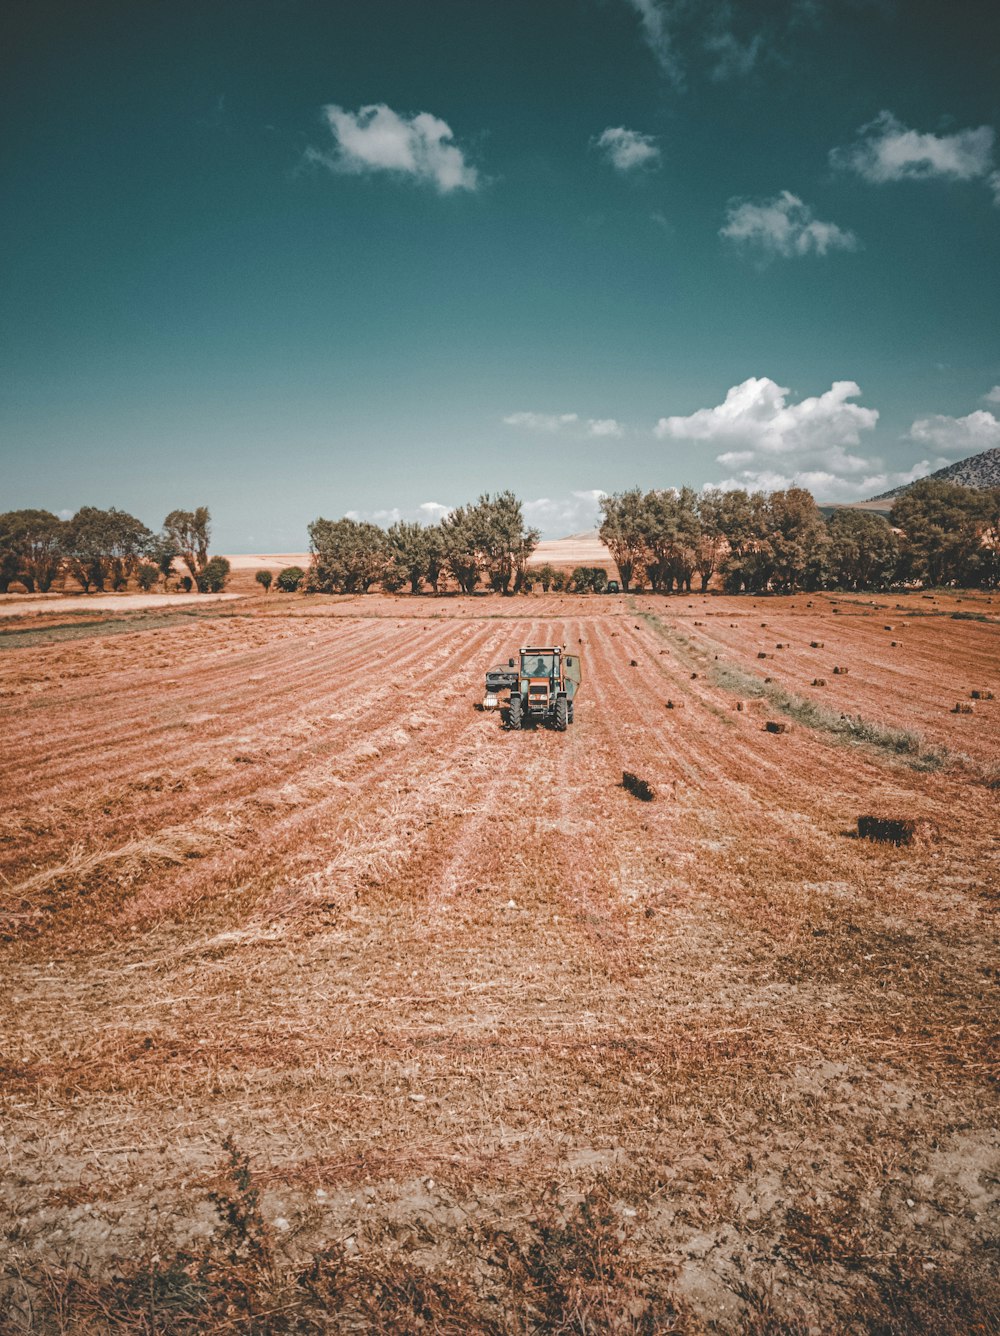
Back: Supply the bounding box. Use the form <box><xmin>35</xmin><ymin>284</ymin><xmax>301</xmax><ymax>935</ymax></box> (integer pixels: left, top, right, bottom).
<box><xmin>0</xmin><ymin>595</ymin><xmax>1000</xmax><ymax>1333</ymax></box>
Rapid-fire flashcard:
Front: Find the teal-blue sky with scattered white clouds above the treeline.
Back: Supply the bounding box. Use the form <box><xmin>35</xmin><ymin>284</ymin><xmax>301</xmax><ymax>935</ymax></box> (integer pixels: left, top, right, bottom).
<box><xmin>0</xmin><ymin>0</ymin><xmax>1000</xmax><ymax>552</ymax></box>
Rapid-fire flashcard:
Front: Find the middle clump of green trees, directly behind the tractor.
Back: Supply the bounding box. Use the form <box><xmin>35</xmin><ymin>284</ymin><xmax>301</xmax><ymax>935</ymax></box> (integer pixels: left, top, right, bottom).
<box><xmin>306</xmin><ymin>492</ymin><xmax>538</xmax><ymax>593</ymax></box>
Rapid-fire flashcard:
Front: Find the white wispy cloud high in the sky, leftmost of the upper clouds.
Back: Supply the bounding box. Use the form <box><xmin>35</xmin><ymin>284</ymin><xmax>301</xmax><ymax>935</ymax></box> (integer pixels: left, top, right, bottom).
<box><xmin>306</xmin><ymin>103</ymin><xmax>479</xmax><ymax>195</ymax></box>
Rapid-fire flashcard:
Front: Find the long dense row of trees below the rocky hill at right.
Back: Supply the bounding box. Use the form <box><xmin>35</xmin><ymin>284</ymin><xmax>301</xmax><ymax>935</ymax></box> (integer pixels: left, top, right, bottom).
<box><xmin>601</xmin><ymin>478</ymin><xmax>1000</xmax><ymax>593</ymax></box>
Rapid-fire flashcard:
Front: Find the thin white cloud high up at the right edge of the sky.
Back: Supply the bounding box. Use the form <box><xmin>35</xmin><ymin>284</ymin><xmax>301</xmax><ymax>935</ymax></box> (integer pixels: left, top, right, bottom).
<box><xmin>830</xmin><ymin>111</ymin><xmax>996</xmax><ymax>188</ymax></box>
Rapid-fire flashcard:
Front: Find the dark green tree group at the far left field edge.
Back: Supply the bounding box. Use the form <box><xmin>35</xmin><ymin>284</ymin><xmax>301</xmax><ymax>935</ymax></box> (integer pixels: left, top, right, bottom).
<box><xmin>0</xmin><ymin>505</ymin><xmax>230</xmax><ymax>593</ymax></box>
